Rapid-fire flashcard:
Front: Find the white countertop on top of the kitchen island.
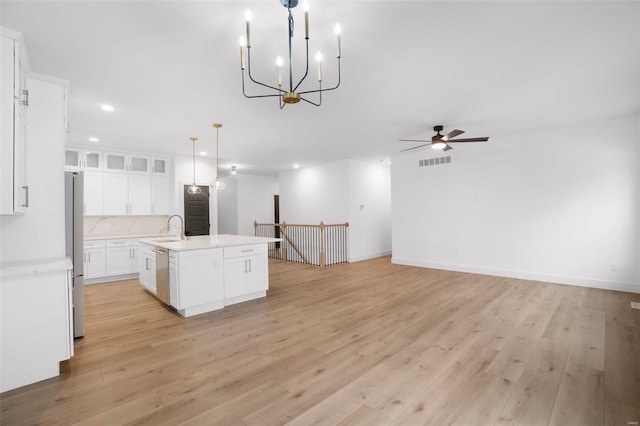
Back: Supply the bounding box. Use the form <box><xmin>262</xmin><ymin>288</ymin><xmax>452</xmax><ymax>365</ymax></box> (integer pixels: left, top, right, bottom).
<box><xmin>140</xmin><ymin>234</ymin><xmax>283</xmax><ymax>251</ymax></box>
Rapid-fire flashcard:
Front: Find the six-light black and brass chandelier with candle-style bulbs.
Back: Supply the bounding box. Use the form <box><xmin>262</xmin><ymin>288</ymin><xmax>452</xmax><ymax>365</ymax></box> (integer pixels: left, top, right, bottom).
<box><xmin>240</xmin><ymin>0</ymin><xmax>341</xmax><ymax>109</ymax></box>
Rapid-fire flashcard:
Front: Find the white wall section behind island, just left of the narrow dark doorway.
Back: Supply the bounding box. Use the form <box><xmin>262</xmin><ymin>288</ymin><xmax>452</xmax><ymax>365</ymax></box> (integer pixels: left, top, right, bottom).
<box><xmin>235</xmin><ymin>173</ymin><xmax>279</xmax><ymax>235</ymax></box>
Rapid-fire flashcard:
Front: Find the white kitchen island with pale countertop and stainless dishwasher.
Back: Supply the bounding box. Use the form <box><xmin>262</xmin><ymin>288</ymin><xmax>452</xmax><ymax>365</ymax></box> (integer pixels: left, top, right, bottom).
<box><xmin>139</xmin><ymin>235</ymin><xmax>282</xmax><ymax>317</ymax></box>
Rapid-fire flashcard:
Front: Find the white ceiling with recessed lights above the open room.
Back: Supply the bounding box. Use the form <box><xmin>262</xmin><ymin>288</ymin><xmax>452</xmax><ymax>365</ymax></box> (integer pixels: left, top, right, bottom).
<box><xmin>0</xmin><ymin>0</ymin><xmax>640</xmax><ymax>174</ymax></box>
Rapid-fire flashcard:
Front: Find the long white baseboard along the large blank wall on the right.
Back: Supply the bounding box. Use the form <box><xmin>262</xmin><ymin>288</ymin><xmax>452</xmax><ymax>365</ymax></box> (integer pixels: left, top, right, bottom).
<box><xmin>391</xmin><ymin>257</ymin><xmax>640</xmax><ymax>293</ymax></box>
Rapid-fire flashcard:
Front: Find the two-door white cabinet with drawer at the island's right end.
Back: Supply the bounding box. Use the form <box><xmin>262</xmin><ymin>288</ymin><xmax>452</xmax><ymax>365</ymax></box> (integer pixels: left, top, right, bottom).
<box><xmin>224</xmin><ymin>244</ymin><xmax>269</xmax><ymax>305</ymax></box>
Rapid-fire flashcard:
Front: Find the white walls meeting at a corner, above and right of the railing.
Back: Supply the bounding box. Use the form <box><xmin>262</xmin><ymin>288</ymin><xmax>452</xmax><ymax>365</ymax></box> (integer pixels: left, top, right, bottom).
<box><xmin>280</xmin><ymin>160</ymin><xmax>391</xmax><ymax>262</ymax></box>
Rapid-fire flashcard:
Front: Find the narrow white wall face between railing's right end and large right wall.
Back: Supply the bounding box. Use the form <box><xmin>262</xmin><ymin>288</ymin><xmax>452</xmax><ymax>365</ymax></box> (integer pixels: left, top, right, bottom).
<box><xmin>348</xmin><ymin>160</ymin><xmax>391</xmax><ymax>262</ymax></box>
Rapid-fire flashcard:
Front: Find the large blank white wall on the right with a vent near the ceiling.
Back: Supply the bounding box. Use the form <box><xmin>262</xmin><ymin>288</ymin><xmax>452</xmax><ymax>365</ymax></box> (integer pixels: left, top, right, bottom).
<box><xmin>391</xmin><ymin>114</ymin><xmax>640</xmax><ymax>292</ymax></box>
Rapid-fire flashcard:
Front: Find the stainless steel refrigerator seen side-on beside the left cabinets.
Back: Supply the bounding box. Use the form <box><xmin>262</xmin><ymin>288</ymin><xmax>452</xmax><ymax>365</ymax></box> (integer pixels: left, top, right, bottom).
<box><xmin>64</xmin><ymin>172</ymin><xmax>84</xmax><ymax>337</ymax></box>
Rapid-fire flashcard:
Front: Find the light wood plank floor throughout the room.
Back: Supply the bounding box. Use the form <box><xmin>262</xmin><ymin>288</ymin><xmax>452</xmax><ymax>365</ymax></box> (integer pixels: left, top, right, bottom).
<box><xmin>0</xmin><ymin>258</ymin><xmax>640</xmax><ymax>426</ymax></box>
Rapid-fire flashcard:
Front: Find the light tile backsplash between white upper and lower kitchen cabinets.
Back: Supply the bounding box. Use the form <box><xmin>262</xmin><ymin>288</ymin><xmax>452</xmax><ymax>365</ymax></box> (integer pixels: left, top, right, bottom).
<box><xmin>84</xmin><ymin>216</ymin><xmax>169</xmax><ymax>238</ymax></box>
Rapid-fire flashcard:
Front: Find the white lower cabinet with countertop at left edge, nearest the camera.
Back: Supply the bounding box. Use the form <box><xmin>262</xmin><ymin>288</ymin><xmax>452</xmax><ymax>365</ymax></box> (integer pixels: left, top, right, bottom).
<box><xmin>0</xmin><ymin>259</ymin><xmax>73</xmax><ymax>392</ymax></box>
